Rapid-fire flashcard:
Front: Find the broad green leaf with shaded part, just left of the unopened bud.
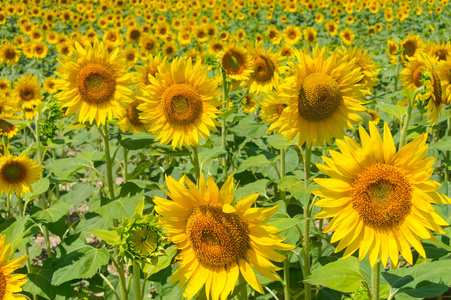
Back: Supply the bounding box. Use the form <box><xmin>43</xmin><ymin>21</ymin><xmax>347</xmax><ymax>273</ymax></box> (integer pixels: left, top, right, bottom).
<box><xmin>52</xmin><ymin>245</ymin><xmax>109</xmax><ymax>285</ymax></box>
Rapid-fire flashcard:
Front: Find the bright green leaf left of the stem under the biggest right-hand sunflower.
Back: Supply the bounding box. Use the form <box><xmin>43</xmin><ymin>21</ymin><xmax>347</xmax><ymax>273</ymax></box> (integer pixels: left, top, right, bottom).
<box><xmin>305</xmin><ymin>256</ymin><xmax>365</xmax><ymax>293</ymax></box>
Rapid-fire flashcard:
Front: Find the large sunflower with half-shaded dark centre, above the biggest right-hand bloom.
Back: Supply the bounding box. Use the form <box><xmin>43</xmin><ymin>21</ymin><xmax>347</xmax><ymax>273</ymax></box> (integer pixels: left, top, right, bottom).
<box><xmin>273</xmin><ymin>46</ymin><xmax>366</xmax><ymax>146</ymax></box>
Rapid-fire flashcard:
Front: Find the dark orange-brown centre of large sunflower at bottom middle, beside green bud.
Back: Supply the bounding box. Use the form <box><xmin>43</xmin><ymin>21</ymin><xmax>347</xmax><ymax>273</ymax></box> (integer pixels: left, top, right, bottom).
<box><xmin>187</xmin><ymin>205</ymin><xmax>249</xmax><ymax>267</ymax></box>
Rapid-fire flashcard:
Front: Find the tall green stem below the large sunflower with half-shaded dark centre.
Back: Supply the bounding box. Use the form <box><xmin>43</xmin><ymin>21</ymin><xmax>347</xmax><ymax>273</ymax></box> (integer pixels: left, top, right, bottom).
<box><xmin>303</xmin><ymin>145</ymin><xmax>312</xmax><ymax>300</ymax></box>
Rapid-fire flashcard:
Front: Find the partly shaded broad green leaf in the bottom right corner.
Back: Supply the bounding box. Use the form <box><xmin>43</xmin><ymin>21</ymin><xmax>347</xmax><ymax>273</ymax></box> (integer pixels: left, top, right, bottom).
<box><xmin>382</xmin><ymin>260</ymin><xmax>451</xmax><ymax>298</ymax></box>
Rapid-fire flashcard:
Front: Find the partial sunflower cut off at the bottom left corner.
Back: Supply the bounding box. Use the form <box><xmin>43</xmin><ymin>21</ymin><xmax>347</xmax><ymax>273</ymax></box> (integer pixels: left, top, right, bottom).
<box><xmin>0</xmin><ymin>235</ymin><xmax>28</xmax><ymax>300</ymax></box>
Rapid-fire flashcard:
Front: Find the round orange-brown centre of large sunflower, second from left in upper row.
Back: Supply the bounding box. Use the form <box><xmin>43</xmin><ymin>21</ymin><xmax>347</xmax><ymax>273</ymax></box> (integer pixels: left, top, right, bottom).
<box><xmin>162</xmin><ymin>84</ymin><xmax>203</xmax><ymax>124</ymax></box>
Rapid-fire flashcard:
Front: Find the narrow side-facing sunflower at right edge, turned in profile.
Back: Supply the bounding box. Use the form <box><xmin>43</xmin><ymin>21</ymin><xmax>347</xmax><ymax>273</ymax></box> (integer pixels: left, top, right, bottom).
<box><xmin>420</xmin><ymin>54</ymin><xmax>443</xmax><ymax>125</ymax></box>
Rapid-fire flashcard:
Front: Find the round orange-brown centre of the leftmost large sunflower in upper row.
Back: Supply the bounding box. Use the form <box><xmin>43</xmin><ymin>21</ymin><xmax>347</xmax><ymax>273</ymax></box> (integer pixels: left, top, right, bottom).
<box><xmin>77</xmin><ymin>64</ymin><xmax>117</xmax><ymax>103</ymax></box>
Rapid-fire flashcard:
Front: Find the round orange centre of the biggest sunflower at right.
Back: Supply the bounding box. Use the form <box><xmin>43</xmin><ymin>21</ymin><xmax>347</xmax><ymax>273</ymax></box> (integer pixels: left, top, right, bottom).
<box><xmin>351</xmin><ymin>163</ymin><xmax>412</xmax><ymax>227</ymax></box>
